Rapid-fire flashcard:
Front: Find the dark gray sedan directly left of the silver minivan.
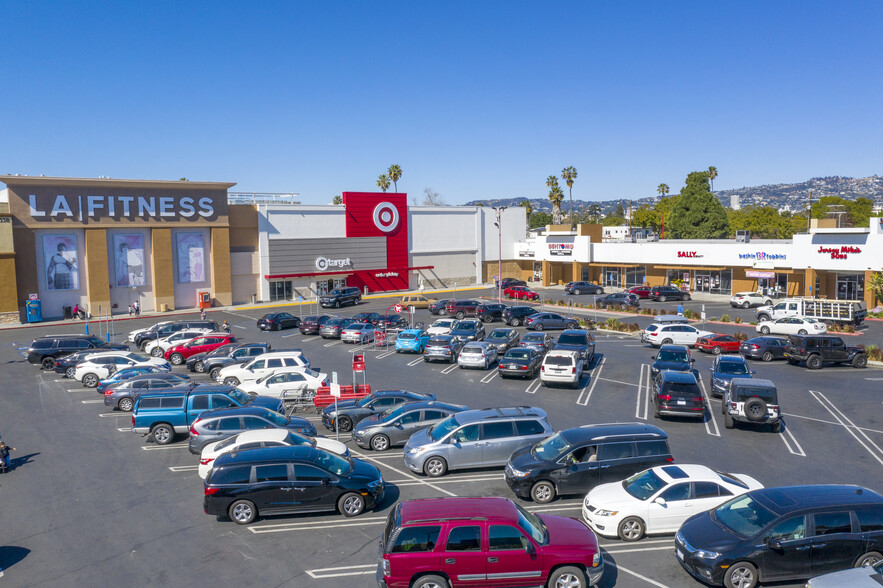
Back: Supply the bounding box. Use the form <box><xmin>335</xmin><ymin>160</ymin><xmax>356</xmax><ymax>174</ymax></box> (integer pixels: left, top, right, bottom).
<box><xmin>353</xmin><ymin>400</ymin><xmax>467</xmax><ymax>451</ymax></box>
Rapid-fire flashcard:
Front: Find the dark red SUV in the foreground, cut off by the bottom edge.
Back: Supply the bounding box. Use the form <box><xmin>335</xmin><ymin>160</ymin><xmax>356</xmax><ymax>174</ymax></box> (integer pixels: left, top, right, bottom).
<box><xmin>376</xmin><ymin>498</ymin><xmax>604</xmax><ymax>588</ymax></box>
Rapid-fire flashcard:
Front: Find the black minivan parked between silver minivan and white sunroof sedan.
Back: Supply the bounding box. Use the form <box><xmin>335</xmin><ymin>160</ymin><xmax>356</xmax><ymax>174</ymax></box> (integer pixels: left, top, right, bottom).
<box><xmin>506</xmin><ymin>423</ymin><xmax>674</xmax><ymax>502</ymax></box>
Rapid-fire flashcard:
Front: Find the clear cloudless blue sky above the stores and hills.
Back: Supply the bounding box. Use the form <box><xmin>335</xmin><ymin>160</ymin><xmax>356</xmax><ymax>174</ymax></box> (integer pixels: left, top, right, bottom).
<box><xmin>0</xmin><ymin>0</ymin><xmax>883</xmax><ymax>204</ymax></box>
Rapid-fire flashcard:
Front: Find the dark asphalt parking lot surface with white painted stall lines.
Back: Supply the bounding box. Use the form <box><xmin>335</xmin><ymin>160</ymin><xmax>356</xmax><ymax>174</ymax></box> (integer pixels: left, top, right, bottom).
<box><xmin>0</xmin><ymin>291</ymin><xmax>883</xmax><ymax>587</ymax></box>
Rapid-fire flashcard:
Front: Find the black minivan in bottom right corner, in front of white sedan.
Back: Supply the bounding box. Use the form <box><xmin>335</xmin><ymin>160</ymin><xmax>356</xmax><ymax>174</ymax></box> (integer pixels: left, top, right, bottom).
<box><xmin>675</xmin><ymin>485</ymin><xmax>883</xmax><ymax>588</ymax></box>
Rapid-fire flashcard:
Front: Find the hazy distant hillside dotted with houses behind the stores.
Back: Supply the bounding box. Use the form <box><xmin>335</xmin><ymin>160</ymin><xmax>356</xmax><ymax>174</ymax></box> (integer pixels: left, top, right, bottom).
<box><xmin>466</xmin><ymin>176</ymin><xmax>883</xmax><ymax>214</ymax></box>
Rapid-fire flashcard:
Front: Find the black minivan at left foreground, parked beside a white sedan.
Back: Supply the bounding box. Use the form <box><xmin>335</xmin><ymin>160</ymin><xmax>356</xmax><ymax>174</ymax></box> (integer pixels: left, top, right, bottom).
<box><xmin>203</xmin><ymin>446</ymin><xmax>384</xmax><ymax>525</ymax></box>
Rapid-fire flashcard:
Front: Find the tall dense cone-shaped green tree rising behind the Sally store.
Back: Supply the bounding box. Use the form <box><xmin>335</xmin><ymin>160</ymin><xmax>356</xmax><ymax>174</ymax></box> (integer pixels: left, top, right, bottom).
<box><xmin>665</xmin><ymin>172</ymin><xmax>730</xmax><ymax>239</ymax></box>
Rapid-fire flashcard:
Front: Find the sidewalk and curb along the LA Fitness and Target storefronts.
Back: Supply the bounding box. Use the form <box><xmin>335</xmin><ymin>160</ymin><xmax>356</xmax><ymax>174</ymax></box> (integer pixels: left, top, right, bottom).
<box><xmin>0</xmin><ymin>284</ymin><xmax>493</xmax><ymax>330</ymax></box>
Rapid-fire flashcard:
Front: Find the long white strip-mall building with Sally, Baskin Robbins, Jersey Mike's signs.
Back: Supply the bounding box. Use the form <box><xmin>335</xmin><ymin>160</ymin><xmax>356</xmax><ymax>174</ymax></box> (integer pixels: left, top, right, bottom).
<box><xmin>504</xmin><ymin>218</ymin><xmax>883</xmax><ymax>308</ymax></box>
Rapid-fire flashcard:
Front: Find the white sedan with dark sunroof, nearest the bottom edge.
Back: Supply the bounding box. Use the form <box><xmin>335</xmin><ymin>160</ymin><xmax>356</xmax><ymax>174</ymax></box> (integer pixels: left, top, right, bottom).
<box><xmin>583</xmin><ymin>465</ymin><xmax>763</xmax><ymax>541</ymax></box>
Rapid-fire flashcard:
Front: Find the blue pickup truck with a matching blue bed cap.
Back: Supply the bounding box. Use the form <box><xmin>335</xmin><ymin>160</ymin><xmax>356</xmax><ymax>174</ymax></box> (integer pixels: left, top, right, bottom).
<box><xmin>132</xmin><ymin>384</ymin><xmax>284</xmax><ymax>445</ymax></box>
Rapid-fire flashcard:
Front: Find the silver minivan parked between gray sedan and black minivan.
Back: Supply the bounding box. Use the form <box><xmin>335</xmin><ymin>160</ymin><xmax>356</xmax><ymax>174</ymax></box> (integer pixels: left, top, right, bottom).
<box><xmin>404</xmin><ymin>406</ymin><xmax>553</xmax><ymax>478</ymax></box>
